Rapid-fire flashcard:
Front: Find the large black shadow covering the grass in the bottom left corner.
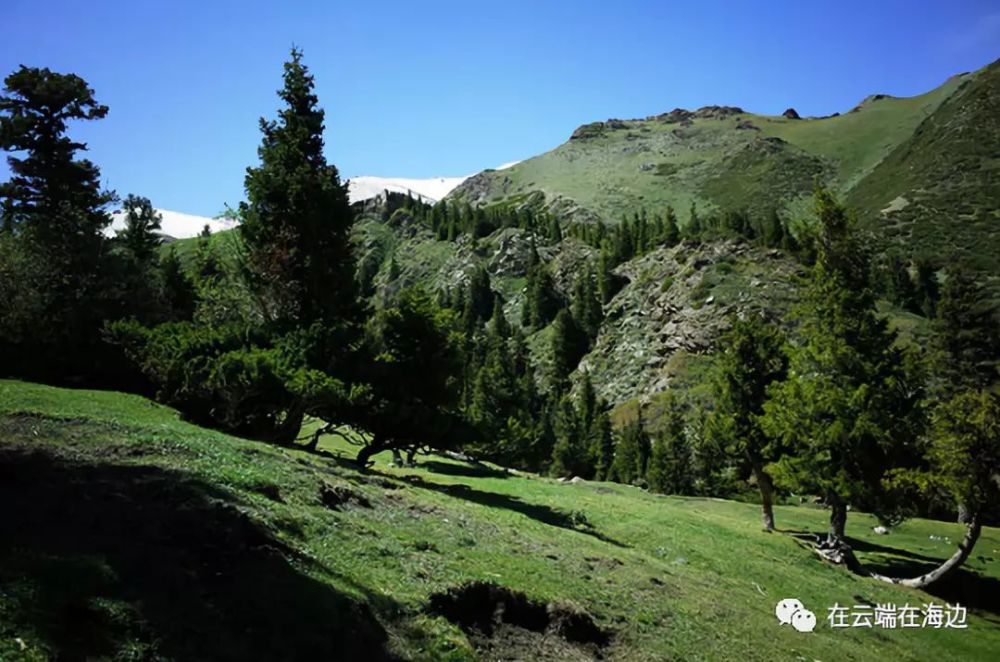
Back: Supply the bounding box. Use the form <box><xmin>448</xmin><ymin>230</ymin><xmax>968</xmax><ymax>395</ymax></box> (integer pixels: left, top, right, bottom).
<box><xmin>0</xmin><ymin>448</ymin><xmax>398</xmax><ymax>660</ymax></box>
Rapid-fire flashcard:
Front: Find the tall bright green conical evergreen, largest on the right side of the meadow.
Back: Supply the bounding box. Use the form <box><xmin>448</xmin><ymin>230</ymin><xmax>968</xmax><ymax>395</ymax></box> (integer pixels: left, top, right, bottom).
<box><xmin>762</xmin><ymin>189</ymin><xmax>921</xmax><ymax>558</ymax></box>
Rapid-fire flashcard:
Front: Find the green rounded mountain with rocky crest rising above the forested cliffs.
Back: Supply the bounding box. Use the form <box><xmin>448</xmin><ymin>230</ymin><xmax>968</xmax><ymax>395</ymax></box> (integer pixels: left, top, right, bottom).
<box><xmin>450</xmin><ymin>63</ymin><xmax>1000</xmax><ymax>249</ymax></box>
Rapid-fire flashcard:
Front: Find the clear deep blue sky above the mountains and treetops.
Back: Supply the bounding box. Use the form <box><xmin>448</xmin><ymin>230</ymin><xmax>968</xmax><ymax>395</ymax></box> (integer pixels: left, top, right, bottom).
<box><xmin>0</xmin><ymin>0</ymin><xmax>1000</xmax><ymax>215</ymax></box>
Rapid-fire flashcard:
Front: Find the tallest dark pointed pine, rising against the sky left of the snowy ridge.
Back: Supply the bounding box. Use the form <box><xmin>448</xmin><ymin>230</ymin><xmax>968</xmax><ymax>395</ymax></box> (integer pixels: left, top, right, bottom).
<box><xmin>239</xmin><ymin>49</ymin><xmax>360</xmax><ymax>329</ymax></box>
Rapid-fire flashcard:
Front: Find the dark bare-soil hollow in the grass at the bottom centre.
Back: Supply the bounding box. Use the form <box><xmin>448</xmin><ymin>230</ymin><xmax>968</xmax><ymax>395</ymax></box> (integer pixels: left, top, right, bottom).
<box><xmin>428</xmin><ymin>582</ymin><xmax>611</xmax><ymax>660</ymax></box>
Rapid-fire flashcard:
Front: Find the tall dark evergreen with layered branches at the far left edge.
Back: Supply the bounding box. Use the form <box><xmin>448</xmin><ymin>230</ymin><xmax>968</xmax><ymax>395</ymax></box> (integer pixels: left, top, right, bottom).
<box><xmin>0</xmin><ymin>66</ymin><xmax>117</xmax><ymax>378</ymax></box>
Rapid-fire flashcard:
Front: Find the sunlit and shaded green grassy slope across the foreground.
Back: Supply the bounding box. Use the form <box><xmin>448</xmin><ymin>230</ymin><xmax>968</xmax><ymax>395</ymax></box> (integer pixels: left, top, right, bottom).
<box><xmin>0</xmin><ymin>381</ymin><xmax>1000</xmax><ymax>660</ymax></box>
